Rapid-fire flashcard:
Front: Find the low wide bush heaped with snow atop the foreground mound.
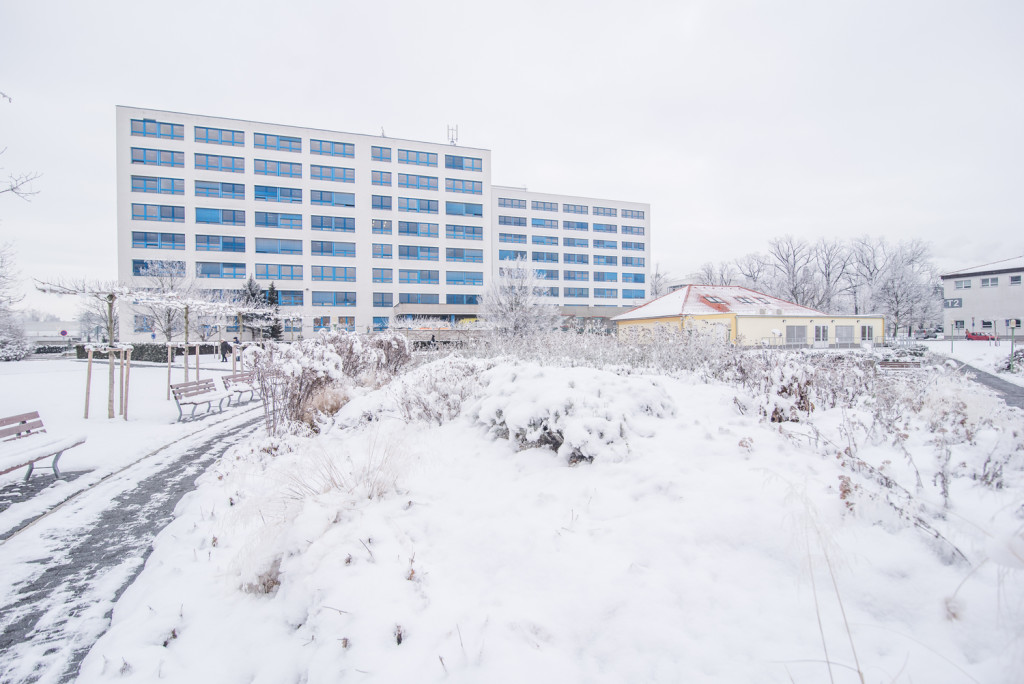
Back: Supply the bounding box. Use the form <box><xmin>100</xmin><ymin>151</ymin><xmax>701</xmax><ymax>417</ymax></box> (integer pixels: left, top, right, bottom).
<box><xmin>472</xmin><ymin>364</ymin><xmax>675</xmax><ymax>464</ymax></box>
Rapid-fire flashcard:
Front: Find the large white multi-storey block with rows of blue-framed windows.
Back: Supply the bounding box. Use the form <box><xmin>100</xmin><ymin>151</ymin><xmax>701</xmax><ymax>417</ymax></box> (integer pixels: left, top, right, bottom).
<box><xmin>117</xmin><ymin>106</ymin><xmax>650</xmax><ymax>340</ymax></box>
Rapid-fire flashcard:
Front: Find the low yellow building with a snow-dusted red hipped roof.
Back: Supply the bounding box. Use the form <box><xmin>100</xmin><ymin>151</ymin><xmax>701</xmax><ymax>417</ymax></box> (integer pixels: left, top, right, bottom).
<box><xmin>612</xmin><ymin>285</ymin><xmax>885</xmax><ymax>348</ymax></box>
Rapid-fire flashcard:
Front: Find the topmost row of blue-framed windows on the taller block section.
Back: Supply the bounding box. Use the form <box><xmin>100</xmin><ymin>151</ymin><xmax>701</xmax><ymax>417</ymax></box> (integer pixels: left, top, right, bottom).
<box><xmin>131</xmin><ymin>119</ymin><xmax>483</xmax><ymax>171</ymax></box>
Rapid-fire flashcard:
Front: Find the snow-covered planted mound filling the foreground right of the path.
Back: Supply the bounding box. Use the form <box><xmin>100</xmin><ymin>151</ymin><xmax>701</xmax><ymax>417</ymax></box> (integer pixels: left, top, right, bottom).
<box><xmin>8</xmin><ymin>343</ymin><xmax>1007</xmax><ymax>683</ymax></box>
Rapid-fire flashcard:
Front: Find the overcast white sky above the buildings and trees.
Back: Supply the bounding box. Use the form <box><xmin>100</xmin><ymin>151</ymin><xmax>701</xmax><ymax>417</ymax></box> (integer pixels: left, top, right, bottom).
<box><xmin>0</xmin><ymin>0</ymin><xmax>1024</xmax><ymax>312</ymax></box>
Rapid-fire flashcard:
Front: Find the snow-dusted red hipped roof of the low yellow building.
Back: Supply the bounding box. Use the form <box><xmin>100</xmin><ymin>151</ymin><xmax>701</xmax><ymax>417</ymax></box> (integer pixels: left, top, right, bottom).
<box><xmin>612</xmin><ymin>285</ymin><xmax>824</xmax><ymax>320</ymax></box>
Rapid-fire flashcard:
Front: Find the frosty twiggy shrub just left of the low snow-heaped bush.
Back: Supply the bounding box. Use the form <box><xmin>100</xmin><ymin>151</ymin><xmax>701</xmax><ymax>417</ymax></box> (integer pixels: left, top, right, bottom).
<box><xmin>387</xmin><ymin>356</ymin><xmax>493</xmax><ymax>425</ymax></box>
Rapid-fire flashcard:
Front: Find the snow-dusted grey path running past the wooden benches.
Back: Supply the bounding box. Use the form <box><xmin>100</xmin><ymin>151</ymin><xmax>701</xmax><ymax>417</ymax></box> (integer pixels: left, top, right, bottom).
<box><xmin>0</xmin><ymin>416</ymin><xmax>262</xmax><ymax>684</ymax></box>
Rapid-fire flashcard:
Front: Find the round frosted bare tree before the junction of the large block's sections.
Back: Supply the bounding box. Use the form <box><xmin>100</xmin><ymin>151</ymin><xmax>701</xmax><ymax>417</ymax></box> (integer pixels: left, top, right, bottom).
<box><xmin>480</xmin><ymin>258</ymin><xmax>561</xmax><ymax>339</ymax></box>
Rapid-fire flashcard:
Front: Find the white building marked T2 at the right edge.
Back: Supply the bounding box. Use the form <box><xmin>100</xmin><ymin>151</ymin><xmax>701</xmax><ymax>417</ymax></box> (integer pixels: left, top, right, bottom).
<box><xmin>941</xmin><ymin>256</ymin><xmax>1024</xmax><ymax>336</ymax></box>
